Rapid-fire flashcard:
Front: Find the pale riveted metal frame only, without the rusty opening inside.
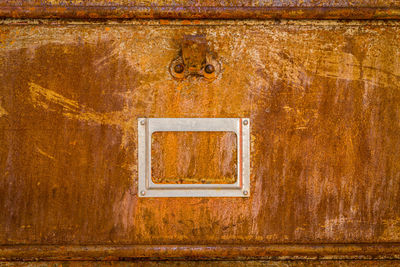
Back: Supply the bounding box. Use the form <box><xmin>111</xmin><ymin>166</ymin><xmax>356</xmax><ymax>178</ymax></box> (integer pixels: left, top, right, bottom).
<box><xmin>138</xmin><ymin>118</ymin><xmax>250</xmax><ymax>197</ymax></box>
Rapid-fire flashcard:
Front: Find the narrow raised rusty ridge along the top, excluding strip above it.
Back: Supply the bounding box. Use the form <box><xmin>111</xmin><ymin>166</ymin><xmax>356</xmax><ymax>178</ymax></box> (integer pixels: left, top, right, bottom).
<box><xmin>0</xmin><ymin>5</ymin><xmax>400</xmax><ymax>20</ymax></box>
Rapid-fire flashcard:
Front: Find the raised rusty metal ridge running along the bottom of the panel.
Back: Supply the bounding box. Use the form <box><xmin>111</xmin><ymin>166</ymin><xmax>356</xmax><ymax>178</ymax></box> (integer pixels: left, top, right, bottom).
<box><xmin>0</xmin><ymin>243</ymin><xmax>400</xmax><ymax>261</ymax></box>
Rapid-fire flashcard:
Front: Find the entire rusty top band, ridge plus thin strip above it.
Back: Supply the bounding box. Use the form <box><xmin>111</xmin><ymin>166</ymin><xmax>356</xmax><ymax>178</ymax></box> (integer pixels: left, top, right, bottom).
<box><xmin>0</xmin><ymin>0</ymin><xmax>400</xmax><ymax>19</ymax></box>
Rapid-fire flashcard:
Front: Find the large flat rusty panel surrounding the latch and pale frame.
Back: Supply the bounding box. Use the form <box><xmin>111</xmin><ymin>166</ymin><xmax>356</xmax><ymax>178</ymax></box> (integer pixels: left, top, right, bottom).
<box><xmin>0</xmin><ymin>21</ymin><xmax>400</xmax><ymax>258</ymax></box>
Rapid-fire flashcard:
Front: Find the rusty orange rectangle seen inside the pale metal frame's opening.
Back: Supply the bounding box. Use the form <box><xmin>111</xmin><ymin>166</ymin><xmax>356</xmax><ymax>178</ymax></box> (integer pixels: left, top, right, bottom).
<box><xmin>151</xmin><ymin>132</ymin><xmax>237</xmax><ymax>184</ymax></box>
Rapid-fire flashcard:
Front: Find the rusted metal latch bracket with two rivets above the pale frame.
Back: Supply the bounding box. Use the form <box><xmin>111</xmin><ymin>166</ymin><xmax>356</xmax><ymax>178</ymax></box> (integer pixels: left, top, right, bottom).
<box><xmin>169</xmin><ymin>35</ymin><xmax>221</xmax><ymax>80</ymax></box>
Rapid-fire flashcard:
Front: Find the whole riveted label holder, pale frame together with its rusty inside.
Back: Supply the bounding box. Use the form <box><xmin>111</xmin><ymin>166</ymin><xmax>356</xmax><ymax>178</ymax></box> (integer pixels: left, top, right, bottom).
<box><xmin>138</xmin><ymin>118</ymin><xmax>250</xmax><ymax>197</ymax></box>
